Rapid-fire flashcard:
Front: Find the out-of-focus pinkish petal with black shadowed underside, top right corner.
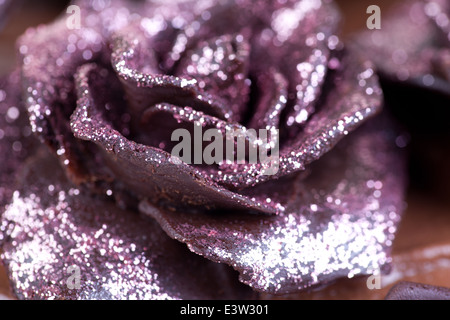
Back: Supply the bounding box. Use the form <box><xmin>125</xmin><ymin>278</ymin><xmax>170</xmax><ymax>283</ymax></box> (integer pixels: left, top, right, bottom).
<box><xmin>354</xmin><ymin>0</ymin><xmax>450</xmax><ymax>135</ymax></box>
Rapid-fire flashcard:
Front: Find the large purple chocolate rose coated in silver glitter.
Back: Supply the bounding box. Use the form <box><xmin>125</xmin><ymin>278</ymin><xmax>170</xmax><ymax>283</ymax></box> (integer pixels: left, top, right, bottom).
<box><xmin>2</xmin><ymin>0</ymin><xmax>404</xmax><ymax>298</ymax></box>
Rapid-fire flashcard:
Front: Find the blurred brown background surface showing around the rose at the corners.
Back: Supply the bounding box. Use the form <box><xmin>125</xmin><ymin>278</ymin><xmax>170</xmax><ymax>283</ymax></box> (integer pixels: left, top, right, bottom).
<box><xmin>0</xmin><ymin>0</ymin><xmax>450</xmax><ymax>299</ymax></box>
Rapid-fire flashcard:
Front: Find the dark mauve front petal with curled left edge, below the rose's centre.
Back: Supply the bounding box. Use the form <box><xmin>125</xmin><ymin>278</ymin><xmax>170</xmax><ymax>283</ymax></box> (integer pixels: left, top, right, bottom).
<box><xmin>70</xmin><ymin>64</ymin><xmax>277</xmax><ymax>213</ymax></box>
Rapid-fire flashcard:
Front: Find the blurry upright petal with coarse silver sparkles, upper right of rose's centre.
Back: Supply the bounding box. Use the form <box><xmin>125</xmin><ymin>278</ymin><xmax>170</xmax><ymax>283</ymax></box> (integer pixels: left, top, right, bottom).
<box><xmin>268</xmin><ymin>1</ymin><xmax>340</xmax><ymax>126</ymax></box>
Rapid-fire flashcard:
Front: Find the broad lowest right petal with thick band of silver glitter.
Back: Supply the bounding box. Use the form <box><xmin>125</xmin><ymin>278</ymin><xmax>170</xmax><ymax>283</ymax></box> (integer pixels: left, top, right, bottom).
<box><xmin>140</xmin><ymin>113</ymin><xmax>405</xmax><ymax>294</ymax></box>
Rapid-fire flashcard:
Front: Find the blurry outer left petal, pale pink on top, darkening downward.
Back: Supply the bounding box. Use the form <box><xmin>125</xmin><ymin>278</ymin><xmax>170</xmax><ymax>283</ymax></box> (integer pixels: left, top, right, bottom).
<box><xmin>18</xmin><ymin>15</ymin><xmax>108</xmax><ymax>182</ymax></box>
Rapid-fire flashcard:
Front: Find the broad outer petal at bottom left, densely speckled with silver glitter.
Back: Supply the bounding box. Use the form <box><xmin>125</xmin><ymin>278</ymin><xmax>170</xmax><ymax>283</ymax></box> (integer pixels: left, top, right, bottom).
<box><xmin>0</xmin><ymin>150</ymin><xmax>254</xmax><ymax>300</ymax></box>
